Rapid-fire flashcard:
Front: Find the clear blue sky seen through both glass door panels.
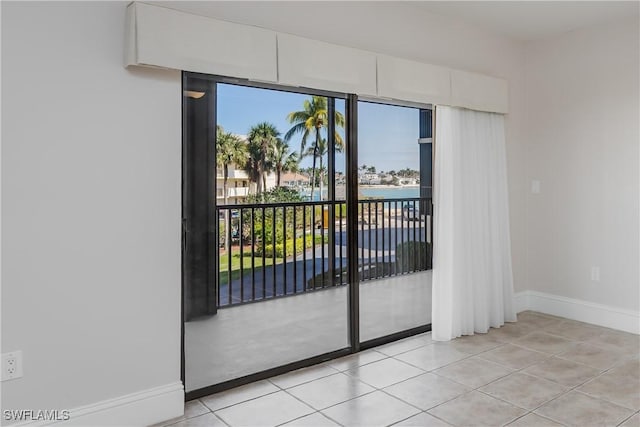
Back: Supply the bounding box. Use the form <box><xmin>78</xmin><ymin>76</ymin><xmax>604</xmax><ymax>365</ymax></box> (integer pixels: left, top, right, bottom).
<box><xmin>217</xmin><ymin>84</ymin><xmax>419</xmax><ymax>171</ymax></box>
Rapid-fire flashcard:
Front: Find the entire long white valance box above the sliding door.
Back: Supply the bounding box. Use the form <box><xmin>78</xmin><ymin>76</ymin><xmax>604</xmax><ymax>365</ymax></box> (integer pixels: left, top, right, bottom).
<box><xmin>125</xmin><ymin>2</ymin><xmax>509</xmax><ymax>114</ymax></box>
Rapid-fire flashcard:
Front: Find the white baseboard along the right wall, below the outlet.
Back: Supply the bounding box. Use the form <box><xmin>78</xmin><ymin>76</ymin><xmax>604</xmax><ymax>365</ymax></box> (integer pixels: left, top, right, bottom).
<box><xmin>513</xmin><ymin>291</ymin><xmax>640</xmax><ymax>334</ymax></box>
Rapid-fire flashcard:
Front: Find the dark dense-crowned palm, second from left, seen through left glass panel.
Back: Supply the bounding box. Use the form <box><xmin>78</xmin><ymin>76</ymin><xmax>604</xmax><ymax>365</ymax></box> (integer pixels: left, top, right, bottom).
<box><xmin>247</xmin><ymin>122</ymin><xmax>280</xmax><ymax>194</ymax></box>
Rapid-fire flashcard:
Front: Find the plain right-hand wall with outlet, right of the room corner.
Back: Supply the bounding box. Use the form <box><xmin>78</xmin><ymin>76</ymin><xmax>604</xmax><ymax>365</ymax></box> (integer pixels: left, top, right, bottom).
<box><xmin>526</xmin><ymin>16</ymin><xmax>640</xmax><ymax>312</ymax></box>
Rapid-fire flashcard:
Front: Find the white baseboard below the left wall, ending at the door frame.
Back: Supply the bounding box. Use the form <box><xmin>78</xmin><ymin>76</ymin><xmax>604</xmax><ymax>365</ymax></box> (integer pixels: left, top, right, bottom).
<box><xmin>13</xmin><ymin>382</ymin><xmax>184</xmax><ymax>427</ymax></box>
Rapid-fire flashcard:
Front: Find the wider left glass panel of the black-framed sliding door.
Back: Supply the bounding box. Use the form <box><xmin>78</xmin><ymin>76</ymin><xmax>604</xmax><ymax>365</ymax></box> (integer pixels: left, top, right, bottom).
<box><xmin>184</xmin><ymin>78</ymin><xmax>349</xmax><ymax>392</ymax></box>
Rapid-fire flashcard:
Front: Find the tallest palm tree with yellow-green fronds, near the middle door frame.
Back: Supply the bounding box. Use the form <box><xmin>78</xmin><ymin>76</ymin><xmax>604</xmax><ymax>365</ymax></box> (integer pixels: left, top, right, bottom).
<box><xmin>284</xmin><ymin>96</ymin><xmax>345</xmax><ymax>198</ymax></box>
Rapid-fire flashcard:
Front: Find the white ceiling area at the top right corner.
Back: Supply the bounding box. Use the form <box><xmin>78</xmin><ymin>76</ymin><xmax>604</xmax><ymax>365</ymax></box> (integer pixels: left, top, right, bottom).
<box><xmin>413</xmin><ymin>1</ymin><xmax>639</xmax><ymax>41</ymax></box>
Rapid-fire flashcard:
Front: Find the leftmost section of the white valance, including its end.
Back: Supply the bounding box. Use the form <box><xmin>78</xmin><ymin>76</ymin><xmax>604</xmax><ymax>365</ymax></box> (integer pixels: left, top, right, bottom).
<box><xmin>125</xmin><ymin>3</ymin><xmax>277</xmax><ymax>82</ymax></box>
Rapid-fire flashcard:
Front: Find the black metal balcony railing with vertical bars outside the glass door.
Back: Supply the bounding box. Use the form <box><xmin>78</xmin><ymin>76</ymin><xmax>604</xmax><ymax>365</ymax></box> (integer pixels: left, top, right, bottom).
<box><xmin>216</xmin><ymin>198</ymin><xmax>432</xmax><ymax>306</ymax></box>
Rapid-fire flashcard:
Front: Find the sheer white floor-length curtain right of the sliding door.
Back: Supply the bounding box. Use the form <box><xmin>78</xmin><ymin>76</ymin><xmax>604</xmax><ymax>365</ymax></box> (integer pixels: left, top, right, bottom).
<box><xmin>432</xmin><ymin>106</ymin><xmax>516</xmax><ymax>341</ymax></box>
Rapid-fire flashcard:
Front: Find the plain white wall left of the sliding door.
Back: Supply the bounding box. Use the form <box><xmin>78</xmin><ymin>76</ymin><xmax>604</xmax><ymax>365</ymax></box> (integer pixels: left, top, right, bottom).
<box><xmin>2</xmin><ymin>2</ymin><xmax>181</xmax><ymax>424</ymax></box>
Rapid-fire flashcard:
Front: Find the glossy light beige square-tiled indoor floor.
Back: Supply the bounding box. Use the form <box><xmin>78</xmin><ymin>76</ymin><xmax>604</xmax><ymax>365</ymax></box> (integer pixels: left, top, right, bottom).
<box><xmin>164</xmin><ymin>312</ymin><xmax>640</xmax><ymax>427</ymax></box>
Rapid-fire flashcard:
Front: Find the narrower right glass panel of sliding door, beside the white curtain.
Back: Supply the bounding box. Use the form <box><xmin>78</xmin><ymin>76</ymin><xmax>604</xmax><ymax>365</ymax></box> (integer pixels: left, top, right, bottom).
<box><xmin>357</xmin><ymin>102</ymin><xmax>431</xmax><ymax>342</ymax></box>
